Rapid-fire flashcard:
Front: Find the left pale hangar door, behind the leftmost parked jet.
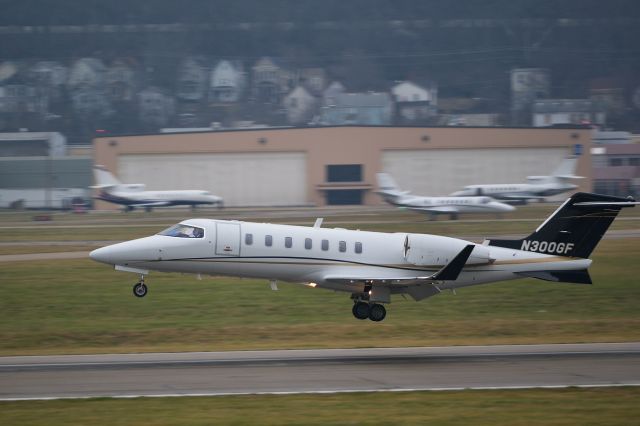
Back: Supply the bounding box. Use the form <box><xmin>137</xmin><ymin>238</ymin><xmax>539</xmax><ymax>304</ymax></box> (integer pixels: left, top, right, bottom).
<box><xmin>118</xmin><ymin>152</ymin><xmax>308</xmax><ymax>206</ymax></box>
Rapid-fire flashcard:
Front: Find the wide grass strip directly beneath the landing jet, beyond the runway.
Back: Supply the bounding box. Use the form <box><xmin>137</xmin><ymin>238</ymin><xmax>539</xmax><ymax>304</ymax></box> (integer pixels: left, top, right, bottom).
<box><xmin>0</xmin><ymin>238</ymin><xmax>640</xmax><ymax>355</ymax></box>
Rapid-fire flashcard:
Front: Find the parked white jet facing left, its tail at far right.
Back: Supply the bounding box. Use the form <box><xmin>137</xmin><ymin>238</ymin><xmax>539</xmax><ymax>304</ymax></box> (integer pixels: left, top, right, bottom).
<box><xmin>451</xmin><ymin>157</ymin><xmax>583</xmax><ymax>204</ymax></box>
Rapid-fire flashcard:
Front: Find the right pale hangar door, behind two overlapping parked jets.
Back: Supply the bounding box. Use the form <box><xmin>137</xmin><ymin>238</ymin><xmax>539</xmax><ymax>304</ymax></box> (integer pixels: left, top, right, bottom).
<box><xmin>382</xmin><ymin>148</ymin><xmax>569</xmax><ymax>198</ymax></box>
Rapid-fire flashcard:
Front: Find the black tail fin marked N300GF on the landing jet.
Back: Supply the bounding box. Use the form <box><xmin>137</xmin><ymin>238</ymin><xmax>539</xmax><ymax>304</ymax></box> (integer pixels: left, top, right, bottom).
<box><xmin>485</xmin><ymin>192</ymin><xmax>639</xmax><ymax>259</ymax></box>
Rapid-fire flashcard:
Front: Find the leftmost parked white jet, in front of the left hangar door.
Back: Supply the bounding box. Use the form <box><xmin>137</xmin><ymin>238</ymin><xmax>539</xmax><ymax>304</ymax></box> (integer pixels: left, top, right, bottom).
<box><xmin>92</xmin><ymin>165</ymin><xmax>223</xmax><ymax>211</ymax></box>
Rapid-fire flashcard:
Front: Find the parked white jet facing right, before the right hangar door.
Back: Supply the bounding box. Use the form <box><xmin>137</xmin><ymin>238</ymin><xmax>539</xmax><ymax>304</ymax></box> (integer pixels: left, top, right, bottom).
<box><xmin>376</xmin><ymin>173</ymin><xmax>515</xmax><ymax>219</ymax></box>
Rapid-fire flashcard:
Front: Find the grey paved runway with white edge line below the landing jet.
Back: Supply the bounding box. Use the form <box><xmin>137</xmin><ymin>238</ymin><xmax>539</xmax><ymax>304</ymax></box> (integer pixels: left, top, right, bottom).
<box><xmin>0</xmin><ymin>343</ymin><xmax>640</xmax><ymax>400</ymax></box>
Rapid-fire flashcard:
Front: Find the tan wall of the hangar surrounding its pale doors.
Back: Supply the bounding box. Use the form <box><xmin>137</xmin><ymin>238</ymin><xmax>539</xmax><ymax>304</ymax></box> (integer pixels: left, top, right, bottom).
<box><xmin>93</xmin><ymin>126</ymin><xmax>591</xmax><ymax>209</ymax></box>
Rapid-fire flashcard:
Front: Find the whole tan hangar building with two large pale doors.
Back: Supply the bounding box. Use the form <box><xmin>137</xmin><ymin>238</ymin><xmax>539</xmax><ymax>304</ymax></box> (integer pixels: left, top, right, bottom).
<box><xmin>93</xmin><ymin>126</ymin><xmax>592</xmax><ymax>209</ymax></box>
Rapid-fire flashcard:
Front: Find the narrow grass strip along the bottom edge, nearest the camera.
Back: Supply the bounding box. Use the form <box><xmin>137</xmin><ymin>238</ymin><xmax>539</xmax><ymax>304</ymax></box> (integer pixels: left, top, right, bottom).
<box><xmin>0</xmin><ymin>387</ymin><xmax>640</xmax><ymax>426</ymax></box>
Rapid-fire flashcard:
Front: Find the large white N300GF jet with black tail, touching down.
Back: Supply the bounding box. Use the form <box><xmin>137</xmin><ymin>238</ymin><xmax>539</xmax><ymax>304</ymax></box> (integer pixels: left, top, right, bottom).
<box><xmin>90</xmin><ymin>193</ymin><xmax>638</xmax><ymax>321</ymax></box>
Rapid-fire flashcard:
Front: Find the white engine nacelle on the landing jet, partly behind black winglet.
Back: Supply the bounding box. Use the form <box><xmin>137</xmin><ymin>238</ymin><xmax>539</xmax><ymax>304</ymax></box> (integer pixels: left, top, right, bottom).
<box><xmin>404</xmin><ymin>234</ymin><xmax>493</xmax><ymax>266</ymax></box>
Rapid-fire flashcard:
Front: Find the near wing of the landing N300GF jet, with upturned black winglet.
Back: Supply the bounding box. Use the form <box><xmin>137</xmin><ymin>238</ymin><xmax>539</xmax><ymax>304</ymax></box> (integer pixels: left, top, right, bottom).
<box><xmin>324</xmin><ymin>244</ymin><xmax>475</xmax><ymax>300</ymax></box>
